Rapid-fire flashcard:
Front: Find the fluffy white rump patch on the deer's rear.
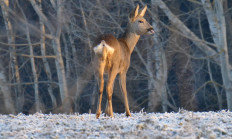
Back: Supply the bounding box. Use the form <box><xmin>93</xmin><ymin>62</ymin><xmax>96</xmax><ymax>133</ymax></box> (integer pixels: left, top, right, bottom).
<box><xmin>93</xmin><ymin>40</ymin><xmax>114</xmax><ymax>54</ymax></box>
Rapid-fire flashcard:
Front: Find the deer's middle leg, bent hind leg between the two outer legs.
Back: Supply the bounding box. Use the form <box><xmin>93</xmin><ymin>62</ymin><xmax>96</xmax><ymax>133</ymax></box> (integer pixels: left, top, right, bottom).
<box><xmin>105</xmin><ymin>70</ymin><xmax>117</xmax><ymax>117</ymax></box>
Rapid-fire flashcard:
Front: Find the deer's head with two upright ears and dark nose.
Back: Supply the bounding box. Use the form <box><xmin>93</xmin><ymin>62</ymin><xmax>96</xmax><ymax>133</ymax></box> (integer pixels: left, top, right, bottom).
<box><xmin>128</xmin><ymin>5</ymin><xmax>155</xmax><ymax>35</ymax></box>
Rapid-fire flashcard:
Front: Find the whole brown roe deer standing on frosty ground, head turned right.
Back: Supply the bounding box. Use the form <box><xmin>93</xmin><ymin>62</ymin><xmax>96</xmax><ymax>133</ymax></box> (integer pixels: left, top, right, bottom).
<box><xmin>93</xmin><ymin>5</ymin><xmax>154</xmax><ymax>118</ymax></box>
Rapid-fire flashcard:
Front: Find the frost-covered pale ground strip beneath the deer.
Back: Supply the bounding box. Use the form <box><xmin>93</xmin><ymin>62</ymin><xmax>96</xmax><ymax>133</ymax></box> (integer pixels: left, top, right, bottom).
<box><xmin>0</xmin><ymin>110</ymin><xmax>232</xmax><ymax>139</ymax></box>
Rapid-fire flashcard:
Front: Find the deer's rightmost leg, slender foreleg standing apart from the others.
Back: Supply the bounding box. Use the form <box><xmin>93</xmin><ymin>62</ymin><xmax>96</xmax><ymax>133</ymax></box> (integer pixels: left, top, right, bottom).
<box><xmin>120</xmin><ymin>72</ymin><xmax>131</xmax><ymax>116</ymax></box>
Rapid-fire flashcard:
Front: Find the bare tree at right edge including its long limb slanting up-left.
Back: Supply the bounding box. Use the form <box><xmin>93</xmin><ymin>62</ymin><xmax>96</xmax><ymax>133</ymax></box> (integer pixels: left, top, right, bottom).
<box><xmin>154</xmin><ymin>0</ymin><xmax>232</xmax><ymax>110</ymax></box>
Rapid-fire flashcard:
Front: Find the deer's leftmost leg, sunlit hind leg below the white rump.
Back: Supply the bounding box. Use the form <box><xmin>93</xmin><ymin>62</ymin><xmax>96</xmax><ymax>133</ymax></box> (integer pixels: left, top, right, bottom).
<box><xmin>96</xmin><ymin>62</ymin><xmax>105</xmax><ymax>118</ymax></box>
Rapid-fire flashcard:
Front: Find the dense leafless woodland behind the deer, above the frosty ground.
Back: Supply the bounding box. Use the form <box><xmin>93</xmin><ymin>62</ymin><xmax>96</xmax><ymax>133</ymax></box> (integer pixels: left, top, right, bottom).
<box><xmin>0</xmin><ymin>0</ymin><xmax>232</xmax><ymax>114</ymax></box>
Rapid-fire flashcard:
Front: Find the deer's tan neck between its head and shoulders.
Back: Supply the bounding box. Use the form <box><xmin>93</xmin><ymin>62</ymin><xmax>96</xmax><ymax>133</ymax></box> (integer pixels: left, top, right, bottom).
<box><xmin>123</xmin><ymin>28</ymin><xmax>140</xmax><ymax>53</ymax></box>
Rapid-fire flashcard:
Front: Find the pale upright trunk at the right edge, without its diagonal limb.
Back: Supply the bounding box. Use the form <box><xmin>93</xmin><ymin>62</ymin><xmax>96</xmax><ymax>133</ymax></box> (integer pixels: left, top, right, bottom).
<box><xmin>201</xmin><ymin>0</ymin><xmax>232</xmax><ymax>111</ymax></box>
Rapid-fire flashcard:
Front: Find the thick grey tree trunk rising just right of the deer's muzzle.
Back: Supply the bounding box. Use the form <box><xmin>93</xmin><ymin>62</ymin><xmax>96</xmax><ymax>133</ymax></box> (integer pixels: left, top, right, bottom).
<box><xmin>147</xmin><ymin>1</ymin><xmax>168</xmax><ymax>112</ymax></box>
